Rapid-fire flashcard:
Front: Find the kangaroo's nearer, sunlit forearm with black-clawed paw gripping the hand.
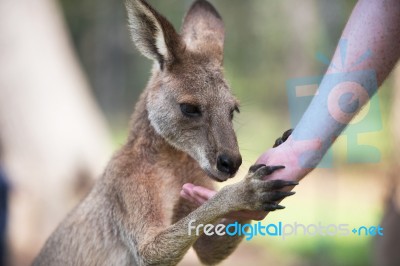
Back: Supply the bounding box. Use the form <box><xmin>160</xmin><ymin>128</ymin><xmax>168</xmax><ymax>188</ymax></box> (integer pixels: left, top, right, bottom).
<box><xmin>122</xmin><ymin>165</ymin><xmax>297</xmax><ymax>266</ymax></box>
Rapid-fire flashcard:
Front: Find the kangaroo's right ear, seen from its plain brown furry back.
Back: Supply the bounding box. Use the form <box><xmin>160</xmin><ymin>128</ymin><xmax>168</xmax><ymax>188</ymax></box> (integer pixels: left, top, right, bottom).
<box><xmin>182</xmin><ymin>0</ymin><xmax>225</xmax><ymax>63</ymax></box>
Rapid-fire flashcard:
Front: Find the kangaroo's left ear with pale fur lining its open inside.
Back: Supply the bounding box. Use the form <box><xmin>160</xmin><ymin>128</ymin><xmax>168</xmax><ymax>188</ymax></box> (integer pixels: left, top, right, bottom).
<box><xmin>125</xmin><ymin>0</ymin><xmax>182</xmax><ymax>69</ymax></box>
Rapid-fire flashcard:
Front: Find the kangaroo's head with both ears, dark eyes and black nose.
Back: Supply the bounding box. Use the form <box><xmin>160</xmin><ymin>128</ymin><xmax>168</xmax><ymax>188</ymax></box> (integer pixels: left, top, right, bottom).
<box><xmin>127</xmin><ymin>0</ymin><xmax>242</xmax><ymax>181</ymax></box>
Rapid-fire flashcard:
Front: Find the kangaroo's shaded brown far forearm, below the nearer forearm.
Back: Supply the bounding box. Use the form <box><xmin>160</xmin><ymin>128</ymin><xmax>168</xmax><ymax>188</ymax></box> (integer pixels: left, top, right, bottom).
<box><xmin>193</xmin><ymin>219</ymin><xmax>251</xmax><ymax>265</ymax></box>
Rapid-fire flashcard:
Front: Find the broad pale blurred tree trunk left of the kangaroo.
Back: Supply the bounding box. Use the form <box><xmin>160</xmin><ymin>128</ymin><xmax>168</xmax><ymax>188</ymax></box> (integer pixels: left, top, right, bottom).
<box><xmin>0</xmin><ymin>0</ymin><xmax>111</xmax><ymax>265</ymax></box>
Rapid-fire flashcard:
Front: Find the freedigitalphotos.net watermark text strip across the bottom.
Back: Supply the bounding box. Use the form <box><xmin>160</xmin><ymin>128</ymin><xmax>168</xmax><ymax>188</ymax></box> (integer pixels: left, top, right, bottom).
<box><xmin>188</xmin><ymin>220</ymin><xmax>383</xmax><ymax>241</ymax></box>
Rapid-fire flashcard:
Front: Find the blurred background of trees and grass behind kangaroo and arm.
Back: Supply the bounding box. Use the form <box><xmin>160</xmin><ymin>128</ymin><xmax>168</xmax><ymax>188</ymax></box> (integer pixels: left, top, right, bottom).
<box><xmin>0</xmin><ymin>0</ymin><xmax>400</xmax><ymax>266</ymax></box>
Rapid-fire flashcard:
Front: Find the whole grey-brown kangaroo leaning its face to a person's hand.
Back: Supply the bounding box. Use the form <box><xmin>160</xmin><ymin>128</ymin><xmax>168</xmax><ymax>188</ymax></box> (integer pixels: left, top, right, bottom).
<box><xmin>33</xmin><ymin>0</ymin><xmax>297</xmax><ymax>266</ymax></box>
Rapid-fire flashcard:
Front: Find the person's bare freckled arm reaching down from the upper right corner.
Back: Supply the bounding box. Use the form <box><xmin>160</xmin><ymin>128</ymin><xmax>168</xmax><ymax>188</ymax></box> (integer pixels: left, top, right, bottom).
<box><xmin>276</xmin><ymin>0</ymin><xmax>400</xmax><ymax>175</ymax></box>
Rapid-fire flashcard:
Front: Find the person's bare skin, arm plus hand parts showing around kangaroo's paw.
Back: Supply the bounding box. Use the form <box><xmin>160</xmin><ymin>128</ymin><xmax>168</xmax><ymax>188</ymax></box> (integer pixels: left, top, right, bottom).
<box><xmin>181</xmin><ymin>0</ymin><xmax>400</xmax><ymax>219</ymax></box>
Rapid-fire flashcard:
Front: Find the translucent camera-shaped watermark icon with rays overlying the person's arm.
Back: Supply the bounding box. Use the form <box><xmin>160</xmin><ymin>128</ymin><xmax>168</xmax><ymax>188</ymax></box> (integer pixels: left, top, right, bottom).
<box><xmin>286</xmin><ymin>39</ymin><xmax>382</xmax><ymax>167</ymax></box>
